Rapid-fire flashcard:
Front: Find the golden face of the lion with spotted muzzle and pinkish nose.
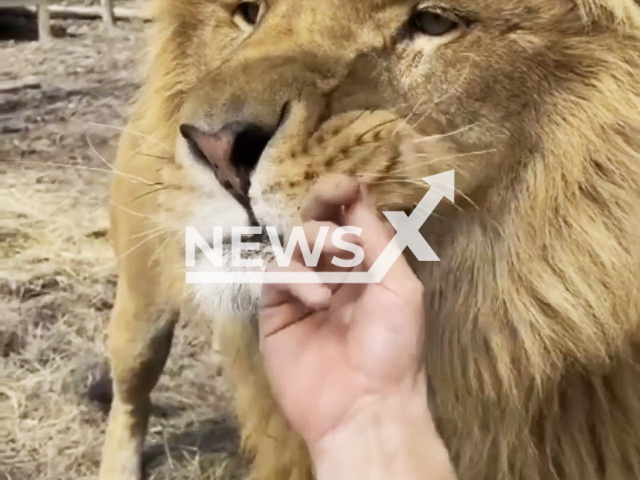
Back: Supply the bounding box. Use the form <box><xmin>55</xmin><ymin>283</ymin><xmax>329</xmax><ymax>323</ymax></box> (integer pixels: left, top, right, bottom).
<box><xmin>145</xmin><ymin>0</ymin><xmax>638</xmax><ymax>316</ymax></box>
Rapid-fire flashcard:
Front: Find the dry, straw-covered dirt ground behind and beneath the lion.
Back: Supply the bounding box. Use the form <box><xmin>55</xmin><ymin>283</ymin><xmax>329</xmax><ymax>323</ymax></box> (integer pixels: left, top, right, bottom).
<box><xmin>0</xmin><ymin>13</ymin><xmax>246</xmax><ymax>480</ymax></box>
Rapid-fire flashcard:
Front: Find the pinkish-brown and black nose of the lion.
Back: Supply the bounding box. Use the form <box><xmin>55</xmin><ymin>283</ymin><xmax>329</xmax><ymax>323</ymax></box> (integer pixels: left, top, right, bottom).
<box><xmin>180</xmin><ymin>122</ymin><xmax>273</xmax><ymax>203</ymax></box>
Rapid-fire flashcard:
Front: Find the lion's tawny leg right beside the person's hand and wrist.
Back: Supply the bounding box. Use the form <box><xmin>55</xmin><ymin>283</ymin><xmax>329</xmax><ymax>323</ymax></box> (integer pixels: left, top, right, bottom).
<box><xmin>219</xmin><ymin>322</ymin><xmax>313</xmax><ymax>480</ymax></box>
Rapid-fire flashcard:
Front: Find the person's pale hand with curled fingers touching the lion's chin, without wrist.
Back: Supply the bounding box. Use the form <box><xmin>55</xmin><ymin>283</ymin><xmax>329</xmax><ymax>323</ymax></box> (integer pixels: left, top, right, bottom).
<box><xmin>260</xmin><ymin>176</ymin><xmax>433</xmax><ymax>452</ymax></box>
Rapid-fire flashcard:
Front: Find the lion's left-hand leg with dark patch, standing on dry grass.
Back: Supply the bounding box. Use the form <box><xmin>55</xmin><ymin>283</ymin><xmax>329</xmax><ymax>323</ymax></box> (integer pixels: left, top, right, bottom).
<box><xmin>100</xmin><ymin>288</ymin><xmax>177</xmax><ymax>480</ymax></box>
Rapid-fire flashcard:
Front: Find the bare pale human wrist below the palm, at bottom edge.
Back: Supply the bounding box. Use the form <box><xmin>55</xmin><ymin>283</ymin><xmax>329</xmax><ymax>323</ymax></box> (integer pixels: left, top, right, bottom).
<box><xmin>310</xmin><ymin>382</ymin><xmax>455</xmax><ymax>480</ymax></box>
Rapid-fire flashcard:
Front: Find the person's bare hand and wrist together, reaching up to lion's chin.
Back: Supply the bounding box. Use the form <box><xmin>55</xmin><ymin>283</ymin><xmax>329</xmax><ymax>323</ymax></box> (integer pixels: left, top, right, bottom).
<box><xmin>260</xmin><ymin>180</ymin><xmax>456</xmax><ymax>480</ymax></box>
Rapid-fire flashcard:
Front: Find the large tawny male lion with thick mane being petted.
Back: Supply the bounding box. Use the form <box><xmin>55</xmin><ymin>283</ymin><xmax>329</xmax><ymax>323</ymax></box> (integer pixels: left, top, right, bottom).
<box><xmin>100</xmin><ymin>0</ymin><xmax>640</xmax><ymax>480</ymax></box>
